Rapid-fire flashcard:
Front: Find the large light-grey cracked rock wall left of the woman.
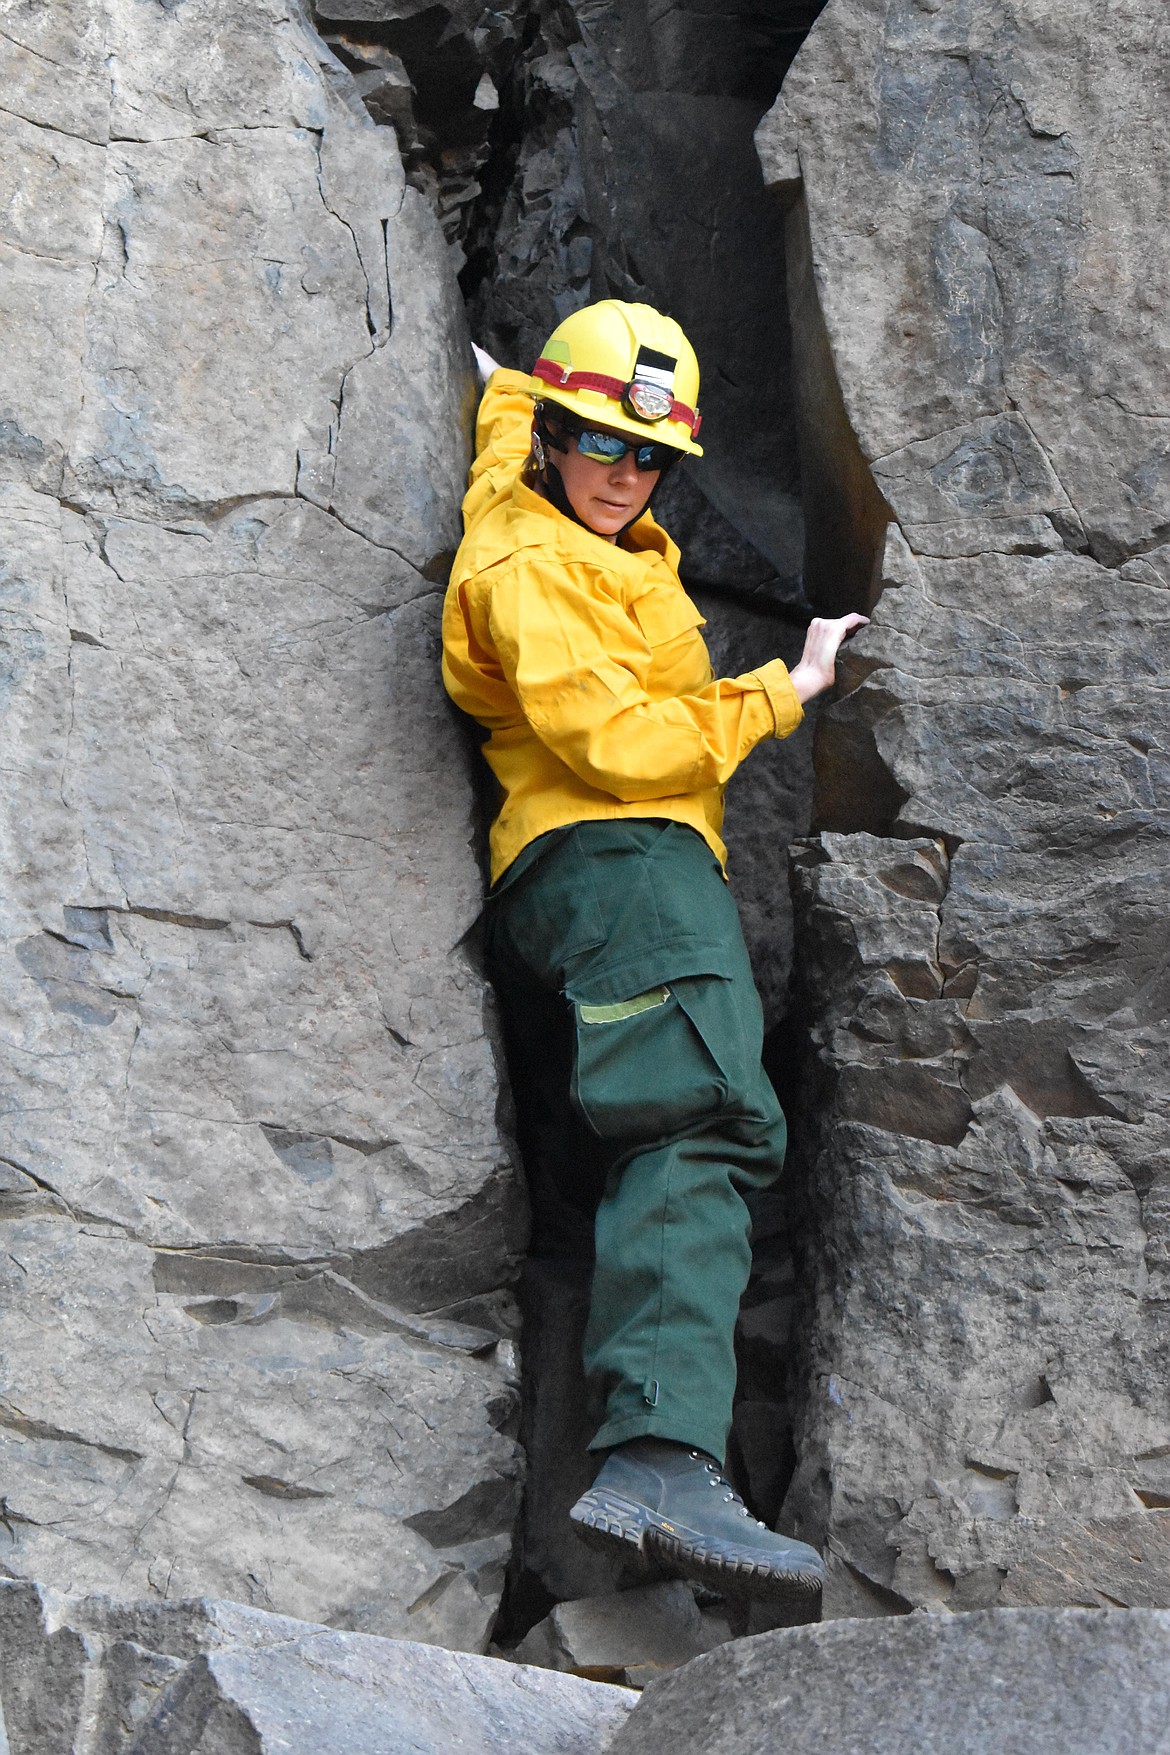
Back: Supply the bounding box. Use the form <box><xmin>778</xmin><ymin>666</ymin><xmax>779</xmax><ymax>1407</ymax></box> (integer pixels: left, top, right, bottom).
<box><xmin>0</xmin><ymin>0</ymin><xmax>521</xmax><ymax>1648</ymax></box>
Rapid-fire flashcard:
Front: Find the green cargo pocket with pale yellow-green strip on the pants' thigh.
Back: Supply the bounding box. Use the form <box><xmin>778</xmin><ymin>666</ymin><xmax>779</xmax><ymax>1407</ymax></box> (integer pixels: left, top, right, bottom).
<box><xmin>572</xmin><ymin>976</ymin><xmax>728</xmax><ymax>1144</ymax></box>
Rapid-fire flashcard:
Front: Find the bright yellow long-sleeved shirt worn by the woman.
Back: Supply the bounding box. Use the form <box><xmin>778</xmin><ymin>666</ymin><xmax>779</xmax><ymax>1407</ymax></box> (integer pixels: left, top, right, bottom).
<box><xmin>442</xmin><ymin>370</ymin><xmax>803</xmax><ymax>883</ymax></box>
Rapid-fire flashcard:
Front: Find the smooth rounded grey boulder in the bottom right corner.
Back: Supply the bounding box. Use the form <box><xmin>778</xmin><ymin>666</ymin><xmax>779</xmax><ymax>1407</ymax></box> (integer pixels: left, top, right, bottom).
<box><xmin>612</xmin><ymin>1609</ymin><xmax>1170</xmax><ymax>1755</ymax></box>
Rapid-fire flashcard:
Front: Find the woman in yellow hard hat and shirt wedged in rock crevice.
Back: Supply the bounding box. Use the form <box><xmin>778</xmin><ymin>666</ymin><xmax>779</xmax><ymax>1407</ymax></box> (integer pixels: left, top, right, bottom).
<box><xmin>444</xmin><ymin>300</ymin><xmax>865</xmax><ymax>1601</ymax></box>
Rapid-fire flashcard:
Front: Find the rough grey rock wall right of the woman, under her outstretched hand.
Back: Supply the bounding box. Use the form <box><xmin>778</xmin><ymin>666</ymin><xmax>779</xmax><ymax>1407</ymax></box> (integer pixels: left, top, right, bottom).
<box><xmin>760</xmin><ymin>0</ymin><xmax>1170</xmax><ymax>1615</ymax></box>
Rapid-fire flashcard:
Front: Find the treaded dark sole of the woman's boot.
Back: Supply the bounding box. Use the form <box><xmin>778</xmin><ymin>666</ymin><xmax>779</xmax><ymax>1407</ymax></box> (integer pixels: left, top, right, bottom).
<box><xmin>568</xmin><ymin>1490</ymin><xmax>823</xmax><ymax>1606</ymax></box>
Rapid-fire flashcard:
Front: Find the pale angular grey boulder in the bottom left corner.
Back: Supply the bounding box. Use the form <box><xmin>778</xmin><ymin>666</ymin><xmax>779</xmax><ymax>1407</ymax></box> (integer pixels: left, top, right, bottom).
<box><xmin>0</xmin><ymin>1581</ymin><xmax>633</xmax><ymax>1755</ymax></box>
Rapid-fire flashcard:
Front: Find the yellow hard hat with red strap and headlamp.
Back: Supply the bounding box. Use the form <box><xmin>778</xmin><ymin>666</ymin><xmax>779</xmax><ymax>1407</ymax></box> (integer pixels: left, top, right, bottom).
<box><xmin>530</xmin><ymin>298</ymin><xmax>703</xmax><ymax>456</ymax></box>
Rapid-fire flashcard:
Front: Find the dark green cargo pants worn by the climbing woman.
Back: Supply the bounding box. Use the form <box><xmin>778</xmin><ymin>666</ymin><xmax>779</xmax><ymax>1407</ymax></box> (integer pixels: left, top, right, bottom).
<box><xmin>488</xmin><ymin>820</ymin><xmax>786</xmax><ymax>1462</ymax></box>
